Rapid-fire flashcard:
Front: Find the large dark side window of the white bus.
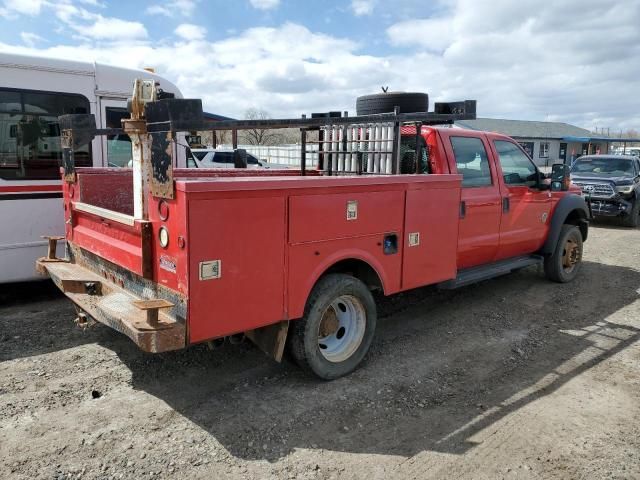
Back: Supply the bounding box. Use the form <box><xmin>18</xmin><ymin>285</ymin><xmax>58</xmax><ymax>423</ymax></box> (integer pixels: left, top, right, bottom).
<box><xmin>0</xmin><ymin>89</ymin><xmax>91</xmax><ymax>180</ymax></box>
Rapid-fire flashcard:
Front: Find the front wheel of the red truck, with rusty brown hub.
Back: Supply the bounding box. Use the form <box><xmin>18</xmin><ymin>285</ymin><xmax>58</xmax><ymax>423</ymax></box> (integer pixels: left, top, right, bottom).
<box><xmin>544</xmin><ymin>225</ymin><xmax>582</xmax><ymax>283</ymax></box>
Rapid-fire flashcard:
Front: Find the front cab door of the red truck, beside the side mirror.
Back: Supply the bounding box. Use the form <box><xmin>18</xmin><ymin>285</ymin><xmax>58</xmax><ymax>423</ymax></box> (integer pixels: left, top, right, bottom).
<box><xmin>491</xmin><ymin>138</ymin><xmax>551</xmax><ymax>260</ymax></box>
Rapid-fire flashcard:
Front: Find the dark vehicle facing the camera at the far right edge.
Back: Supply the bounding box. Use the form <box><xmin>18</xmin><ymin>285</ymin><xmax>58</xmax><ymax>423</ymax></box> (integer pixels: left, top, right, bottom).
<box><xmin>571</xmin><ymin>155</ymin><xmax>640</xmax><ymax>227</ymax></box>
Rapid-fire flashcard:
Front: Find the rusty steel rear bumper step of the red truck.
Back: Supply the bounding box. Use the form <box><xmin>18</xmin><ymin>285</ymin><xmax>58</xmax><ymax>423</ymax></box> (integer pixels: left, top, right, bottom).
<box><xmin>38</xmin><ymin>259</ymin><xmax>186</xmax><ymax>353</ymax></box>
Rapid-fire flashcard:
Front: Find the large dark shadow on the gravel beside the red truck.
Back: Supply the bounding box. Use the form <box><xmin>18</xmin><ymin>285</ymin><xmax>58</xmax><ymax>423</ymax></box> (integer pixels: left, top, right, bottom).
<box><xmin>110</xmin><ymin>262</ymin><xmax>640</xmax><ymax>461</ymax></box>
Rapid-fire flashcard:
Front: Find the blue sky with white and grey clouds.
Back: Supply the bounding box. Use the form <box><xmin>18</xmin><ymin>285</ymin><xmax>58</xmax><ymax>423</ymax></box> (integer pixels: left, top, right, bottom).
<box><xmin>0</xmin><ymin>0</ymin><xmax>640</xmax><ymax>133</ymax></box>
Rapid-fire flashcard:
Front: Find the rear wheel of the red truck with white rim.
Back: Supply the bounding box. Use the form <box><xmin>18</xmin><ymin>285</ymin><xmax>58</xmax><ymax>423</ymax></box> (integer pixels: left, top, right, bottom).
<box><xmin>289</xmin><ymin>274</ymin><xmax>377</xmax><ymax>380</ymax></box>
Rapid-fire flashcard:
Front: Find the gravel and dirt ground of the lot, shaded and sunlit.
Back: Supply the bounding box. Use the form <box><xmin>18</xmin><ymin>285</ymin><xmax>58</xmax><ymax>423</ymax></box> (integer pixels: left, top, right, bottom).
<box><xmin>0</xmin><ymin>225</ymin><xmax>640</xmax><ymax>480</ymax></box>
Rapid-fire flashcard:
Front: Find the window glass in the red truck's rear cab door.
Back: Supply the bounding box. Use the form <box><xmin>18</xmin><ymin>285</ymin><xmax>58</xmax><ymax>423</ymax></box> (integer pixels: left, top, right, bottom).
<box><xmin>451</xmin><ymin>137</ymin><xmax>492</xmax><ymax>187</ymax></box>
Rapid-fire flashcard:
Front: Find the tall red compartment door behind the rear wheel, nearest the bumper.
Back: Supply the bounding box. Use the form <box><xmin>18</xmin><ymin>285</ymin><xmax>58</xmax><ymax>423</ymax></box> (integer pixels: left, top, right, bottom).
<box><xmin>187</xmin><ymin>197</ymin><xmax>285</xmax><ymax>343</ymax></box>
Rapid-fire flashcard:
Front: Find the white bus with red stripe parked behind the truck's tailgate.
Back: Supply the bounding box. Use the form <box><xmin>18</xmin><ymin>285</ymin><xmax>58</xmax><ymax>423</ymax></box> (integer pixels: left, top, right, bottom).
<box><xmin>0</xmin><ymin>53</ymin><xmax>184</xmax><ymax>283</ymax></box>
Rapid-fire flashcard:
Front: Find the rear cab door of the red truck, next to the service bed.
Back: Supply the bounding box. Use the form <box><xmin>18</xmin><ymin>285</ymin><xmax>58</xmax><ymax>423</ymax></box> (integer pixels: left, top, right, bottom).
<box><xmin>441</xmin><ymin>130</ymin><xmax>501</xmax><ymax>269</ymax></box>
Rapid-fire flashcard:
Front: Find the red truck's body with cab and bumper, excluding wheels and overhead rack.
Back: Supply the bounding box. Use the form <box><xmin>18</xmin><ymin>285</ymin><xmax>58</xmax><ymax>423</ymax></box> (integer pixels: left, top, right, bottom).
<box><xmin>40</xmin><ymin>112</ymin><xmax>586</xmax><ymax>378</ymax></box>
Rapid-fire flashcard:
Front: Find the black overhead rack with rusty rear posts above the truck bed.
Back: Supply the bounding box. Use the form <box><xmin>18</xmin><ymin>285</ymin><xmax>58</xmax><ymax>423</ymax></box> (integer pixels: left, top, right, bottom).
<box><xmin>60</xmin><ymin>80</ymin><xmax>476</xmax><ymax>202</ymax></box>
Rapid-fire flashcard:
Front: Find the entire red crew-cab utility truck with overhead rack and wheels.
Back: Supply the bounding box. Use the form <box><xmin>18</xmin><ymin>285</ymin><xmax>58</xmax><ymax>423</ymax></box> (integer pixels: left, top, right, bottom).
<box><xmin>38</xmin><ymin>85</ymin><xmax>588</xmax><ymax>379</ymax></box>
